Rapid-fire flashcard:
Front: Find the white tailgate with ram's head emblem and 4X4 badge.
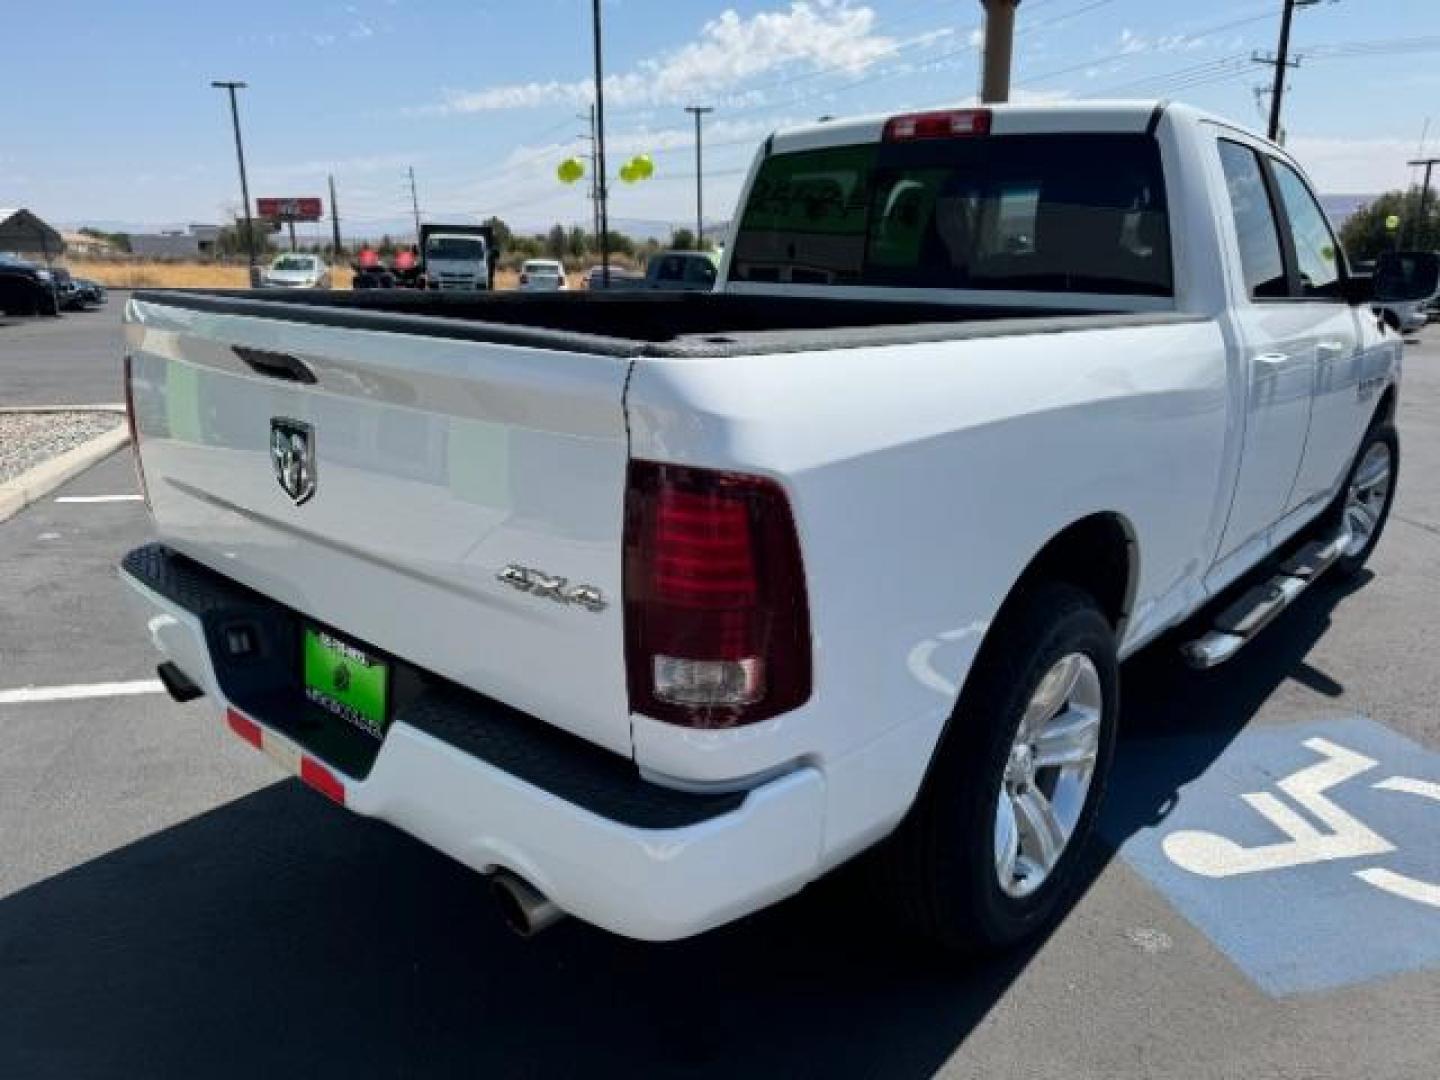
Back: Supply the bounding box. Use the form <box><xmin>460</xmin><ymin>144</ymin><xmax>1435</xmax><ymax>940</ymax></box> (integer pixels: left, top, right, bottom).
<box><xmin>125</xmin><ymin>298</ymin><xmax>631</xmax><ymax>755</ymax></box>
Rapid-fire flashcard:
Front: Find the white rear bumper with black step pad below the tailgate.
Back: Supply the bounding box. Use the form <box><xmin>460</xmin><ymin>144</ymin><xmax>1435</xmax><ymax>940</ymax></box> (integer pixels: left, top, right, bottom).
<box><xmin>121</xmin><ymin>546</ymin><xmax>825</xmax><ymax>940</ymax></box>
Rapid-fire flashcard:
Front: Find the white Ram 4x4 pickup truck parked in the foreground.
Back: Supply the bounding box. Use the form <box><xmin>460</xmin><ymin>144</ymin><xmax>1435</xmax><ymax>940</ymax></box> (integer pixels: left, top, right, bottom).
<box><xmin>122</xmin><ymin>102</ymin><xmax>1401</xmax><ymax>950</ymax></box>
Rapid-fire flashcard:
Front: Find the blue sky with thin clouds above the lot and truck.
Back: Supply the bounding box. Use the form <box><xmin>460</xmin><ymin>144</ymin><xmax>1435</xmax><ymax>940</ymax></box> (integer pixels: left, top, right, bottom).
<box><xmin>0</xmin><ymin>0</ymin><xmax>1440</xmax><ymax>232</ymax></box>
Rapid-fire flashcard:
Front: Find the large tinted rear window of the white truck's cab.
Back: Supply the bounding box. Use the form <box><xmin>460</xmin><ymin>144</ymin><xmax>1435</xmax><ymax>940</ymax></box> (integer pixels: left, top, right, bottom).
<box><xmin>733</xmin><ymin>134</ymin><xmax>1172</xmax><ymax>297</ymax></box>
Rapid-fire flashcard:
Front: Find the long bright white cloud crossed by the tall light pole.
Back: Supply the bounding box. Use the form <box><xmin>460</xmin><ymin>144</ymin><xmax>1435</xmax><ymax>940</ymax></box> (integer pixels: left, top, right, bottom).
<box><xmin>423</xmin><ymin>0</ymin><xmax>900</xmax><ymax>114</ymax></box>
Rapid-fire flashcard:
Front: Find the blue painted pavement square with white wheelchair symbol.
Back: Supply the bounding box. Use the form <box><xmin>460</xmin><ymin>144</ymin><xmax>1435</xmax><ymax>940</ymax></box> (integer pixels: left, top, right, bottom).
<box><xmin>1102</xmin><ymin>717</ymin><xmax>1440</xmax><ymax>995</ymax></box>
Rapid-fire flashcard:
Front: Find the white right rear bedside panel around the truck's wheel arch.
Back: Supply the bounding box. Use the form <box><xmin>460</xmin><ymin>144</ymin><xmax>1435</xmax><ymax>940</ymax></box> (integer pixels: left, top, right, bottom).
<box><xmin>628</xmin><ymin>320</ymin><xmax>1228</xmax><ymax>861</ymax></box>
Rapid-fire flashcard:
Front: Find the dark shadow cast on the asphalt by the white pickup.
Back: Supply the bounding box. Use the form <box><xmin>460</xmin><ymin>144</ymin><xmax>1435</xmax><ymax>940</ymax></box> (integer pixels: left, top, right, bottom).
<box><xmin>0</xmin><ymin>576</ymin><xmax>1354</xmax><ymax>1080</ymax></box>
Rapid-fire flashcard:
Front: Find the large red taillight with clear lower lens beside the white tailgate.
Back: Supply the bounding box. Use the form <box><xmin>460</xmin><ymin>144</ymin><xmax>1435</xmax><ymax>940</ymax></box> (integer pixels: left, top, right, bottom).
<box><xmin>625</xmin><ymin>461</ymin><xmax>811</xmax><ymax>727</ymax></box>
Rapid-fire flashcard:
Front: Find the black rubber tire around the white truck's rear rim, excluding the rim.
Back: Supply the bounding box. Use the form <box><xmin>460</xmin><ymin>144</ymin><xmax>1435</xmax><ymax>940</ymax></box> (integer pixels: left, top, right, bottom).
<box><xmin>878</xmin><ymin>583</ymin><xmax>1119</xmax><ymax>955</ymax></box>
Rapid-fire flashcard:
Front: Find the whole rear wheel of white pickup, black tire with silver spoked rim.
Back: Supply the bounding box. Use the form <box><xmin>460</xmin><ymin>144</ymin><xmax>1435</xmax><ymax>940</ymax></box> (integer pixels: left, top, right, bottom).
<box><xmin>881</xmin><ymin>583</ymin><xmax>1119</xmax><ymax>952</ymax></box>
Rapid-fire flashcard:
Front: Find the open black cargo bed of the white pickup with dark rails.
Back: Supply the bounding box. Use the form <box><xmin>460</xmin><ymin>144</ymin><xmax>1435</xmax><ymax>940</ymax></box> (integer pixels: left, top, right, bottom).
<box><xmin>135</xmin><ymin>289</ymin><xmax>1195</xmax><ymax>357</ymax></box>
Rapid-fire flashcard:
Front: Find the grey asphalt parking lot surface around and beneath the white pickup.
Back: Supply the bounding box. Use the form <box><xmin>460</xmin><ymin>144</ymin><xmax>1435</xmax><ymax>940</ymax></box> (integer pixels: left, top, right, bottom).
<box><xmin>0</xmin><ymin>306</ymin><xmax>1440</xmax><ymax>1080</ymax></box>
